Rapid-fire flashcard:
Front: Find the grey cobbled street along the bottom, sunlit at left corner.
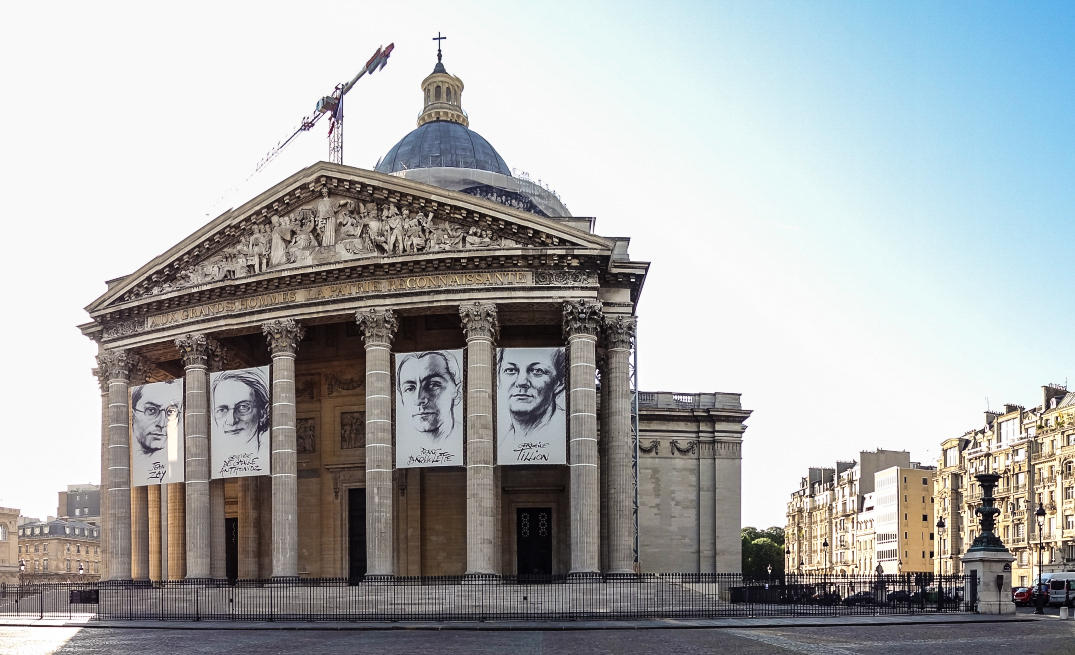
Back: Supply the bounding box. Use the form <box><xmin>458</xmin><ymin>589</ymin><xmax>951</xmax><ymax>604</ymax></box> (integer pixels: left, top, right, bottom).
<box><xmin>0</xmin><ymin>618</ymin><xmax>1075</xmax><ymax>655</ymax></box>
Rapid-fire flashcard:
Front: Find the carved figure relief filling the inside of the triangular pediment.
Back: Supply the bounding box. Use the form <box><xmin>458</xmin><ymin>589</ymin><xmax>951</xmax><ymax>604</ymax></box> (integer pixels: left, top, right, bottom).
<box><xmin>124</xmin><ymin>188</ymin><xmax>521</xmax><ymax>300</ymax></box>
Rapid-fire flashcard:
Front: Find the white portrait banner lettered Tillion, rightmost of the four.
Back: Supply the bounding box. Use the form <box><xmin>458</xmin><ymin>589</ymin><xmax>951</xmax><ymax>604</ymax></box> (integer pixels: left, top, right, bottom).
<box><xmin>497</xmin><ymin>347</ymin><xmax>568</xmax><ymax>465</ymax></box>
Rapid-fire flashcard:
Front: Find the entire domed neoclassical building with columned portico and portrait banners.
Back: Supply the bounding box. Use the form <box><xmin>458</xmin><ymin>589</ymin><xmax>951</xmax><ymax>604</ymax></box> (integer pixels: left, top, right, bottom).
<box><xmin>81</xmin><ymin>58</ymin><xmax>749</xmax><ymax>581</ymax></box>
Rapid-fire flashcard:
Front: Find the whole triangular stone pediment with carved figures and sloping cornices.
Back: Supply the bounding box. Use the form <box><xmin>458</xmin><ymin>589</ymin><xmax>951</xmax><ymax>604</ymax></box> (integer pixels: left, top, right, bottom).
<box><xmin>86</xmin><ymin>162</ymin><xmax>615</xmax><ymax>314</ymax></box>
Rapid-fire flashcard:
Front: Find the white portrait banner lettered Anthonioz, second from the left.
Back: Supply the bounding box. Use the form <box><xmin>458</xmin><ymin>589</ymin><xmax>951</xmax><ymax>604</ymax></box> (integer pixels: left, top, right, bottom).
<box><xmin>209</xmin><ymin>366</ymin><xmax>272</xmax><ymax>480</ymax></box>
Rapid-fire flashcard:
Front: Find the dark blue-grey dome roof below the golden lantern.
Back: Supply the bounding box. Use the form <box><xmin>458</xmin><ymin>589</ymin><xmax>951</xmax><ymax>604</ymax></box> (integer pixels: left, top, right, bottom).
<box><xmin>375</xmin><ymin>120</ymin><xmax>512</xmax><ymax>176</ymax></box>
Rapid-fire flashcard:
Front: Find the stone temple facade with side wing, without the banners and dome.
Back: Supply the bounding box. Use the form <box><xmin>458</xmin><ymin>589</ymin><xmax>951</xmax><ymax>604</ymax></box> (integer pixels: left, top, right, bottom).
<box><xmin>82</xmin><ymin>154</ymin><xmax>749</xmax><ymax>580</ymax></box>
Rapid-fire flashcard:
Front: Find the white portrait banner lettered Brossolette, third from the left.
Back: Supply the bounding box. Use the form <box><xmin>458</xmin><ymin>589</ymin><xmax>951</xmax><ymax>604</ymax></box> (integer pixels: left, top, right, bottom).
<box><xmin>396</xmin><ymin>351</ymin><xmax>463</xmax><ymax>469</ymax></box>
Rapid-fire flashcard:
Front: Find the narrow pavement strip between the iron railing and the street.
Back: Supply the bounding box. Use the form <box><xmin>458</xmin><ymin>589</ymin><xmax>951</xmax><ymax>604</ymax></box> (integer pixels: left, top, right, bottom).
<box><xmin>0</xmin><ymin>614</ymin><xmax>1040</xmax><ymax>631</ymax></box>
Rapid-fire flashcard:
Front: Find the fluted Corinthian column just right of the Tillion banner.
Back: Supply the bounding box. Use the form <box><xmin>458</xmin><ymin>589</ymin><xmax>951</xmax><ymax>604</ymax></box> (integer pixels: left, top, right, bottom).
<box><xmin>563</xmin><ymin>300</ymin><xmax>601</xmax><ymax>576</ymax></box>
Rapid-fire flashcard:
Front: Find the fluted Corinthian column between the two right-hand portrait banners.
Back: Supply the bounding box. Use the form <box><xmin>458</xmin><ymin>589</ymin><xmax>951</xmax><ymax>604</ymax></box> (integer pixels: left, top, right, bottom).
<box><xmin>459</xmin><ymin>302</ymin><xmax>500</xmax><ymax>576</ymax></box>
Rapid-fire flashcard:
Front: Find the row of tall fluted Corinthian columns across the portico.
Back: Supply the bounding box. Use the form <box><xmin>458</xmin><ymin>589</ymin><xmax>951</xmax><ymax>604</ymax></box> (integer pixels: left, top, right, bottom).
<box><xmin>98</xmin><ymin>300</ymin><xmax>635</xmax><ymax>580</ymax></box>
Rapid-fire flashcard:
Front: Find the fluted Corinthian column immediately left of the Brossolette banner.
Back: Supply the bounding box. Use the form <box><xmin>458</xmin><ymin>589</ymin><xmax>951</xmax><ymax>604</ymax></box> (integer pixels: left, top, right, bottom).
<box><xmin>355</xmin><ymin>310</ymin><xmax>399</xmax><ymax>578</ymax></box>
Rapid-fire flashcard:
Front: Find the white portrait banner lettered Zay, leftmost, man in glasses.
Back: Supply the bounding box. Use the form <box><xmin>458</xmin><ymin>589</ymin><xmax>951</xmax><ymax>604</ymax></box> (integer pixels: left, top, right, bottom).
<box><xmin>130</xmin><ymin>380</ymin><xmax>184</xmax><ymax>487</ymax></box>
